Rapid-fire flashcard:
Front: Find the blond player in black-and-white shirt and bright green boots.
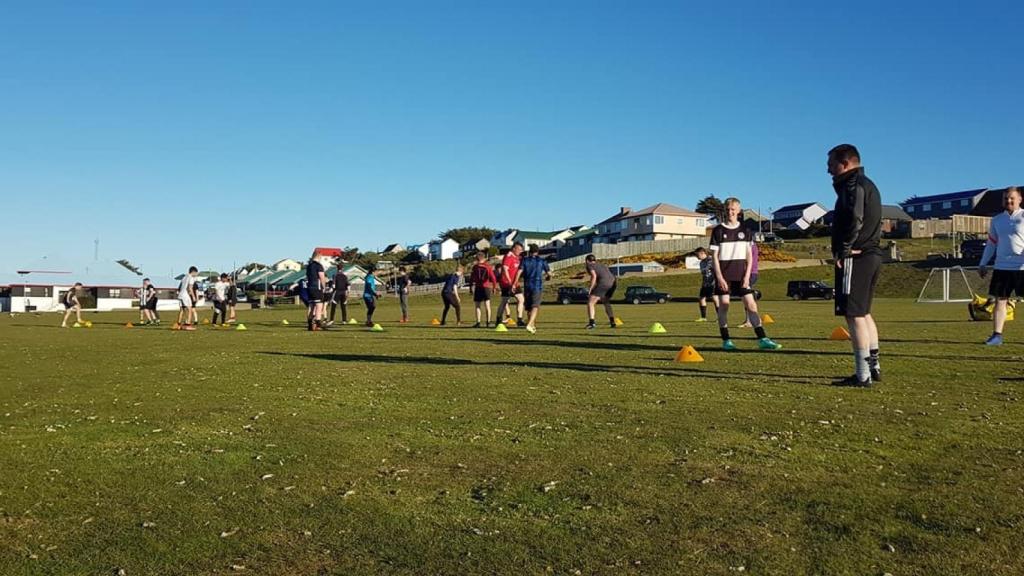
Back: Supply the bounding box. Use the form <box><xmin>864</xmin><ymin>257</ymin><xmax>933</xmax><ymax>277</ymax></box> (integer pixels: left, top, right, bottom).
<box><xmin>711</xmin><ymin>198</ymin><xmax>782</xmax><ymax>352</ymax></box>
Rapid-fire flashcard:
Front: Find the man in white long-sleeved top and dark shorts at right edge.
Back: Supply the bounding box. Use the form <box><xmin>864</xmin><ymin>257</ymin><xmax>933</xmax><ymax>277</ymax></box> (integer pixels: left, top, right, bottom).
<box><xmin>978</xmin><ymin>187</ymin><xmax>1024</xmax><ymax>346</ymax></box>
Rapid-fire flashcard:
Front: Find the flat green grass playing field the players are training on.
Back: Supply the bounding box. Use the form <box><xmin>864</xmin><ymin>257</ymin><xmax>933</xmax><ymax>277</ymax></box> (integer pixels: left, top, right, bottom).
<box><xmin>0</xmin><ymin>291</ymin><xmax>1024</xmax><ymax>576</ymax></box>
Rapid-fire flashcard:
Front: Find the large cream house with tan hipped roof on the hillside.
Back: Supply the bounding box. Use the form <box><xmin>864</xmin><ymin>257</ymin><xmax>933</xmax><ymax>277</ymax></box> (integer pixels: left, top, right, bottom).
<box><xmin>593</xmin><ymin>203</ymin><xmax>708</xmax><ymax>244</ymax></box>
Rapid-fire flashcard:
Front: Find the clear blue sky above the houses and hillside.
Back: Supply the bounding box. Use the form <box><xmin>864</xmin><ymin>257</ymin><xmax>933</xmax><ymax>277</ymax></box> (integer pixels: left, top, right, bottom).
<box><xmin>0</xmin><ymin>0</ymin><xmax>1024</xmax><ymax>274</ymax></box>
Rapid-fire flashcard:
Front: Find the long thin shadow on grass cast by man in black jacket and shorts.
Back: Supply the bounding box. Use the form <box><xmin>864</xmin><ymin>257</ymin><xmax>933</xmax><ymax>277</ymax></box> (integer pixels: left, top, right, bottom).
<box><xmin>259</xmin><ymin>352</ymin><xmax>830</xmax><ymax>383</ymax></box>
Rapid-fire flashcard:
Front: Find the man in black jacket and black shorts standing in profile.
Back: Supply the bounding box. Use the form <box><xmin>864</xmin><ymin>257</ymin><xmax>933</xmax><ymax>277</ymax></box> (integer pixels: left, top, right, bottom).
<box><xmin>828</xmin><ymin>145</ymin><xmax>882</xmax><ymax>387</ymax></box>
